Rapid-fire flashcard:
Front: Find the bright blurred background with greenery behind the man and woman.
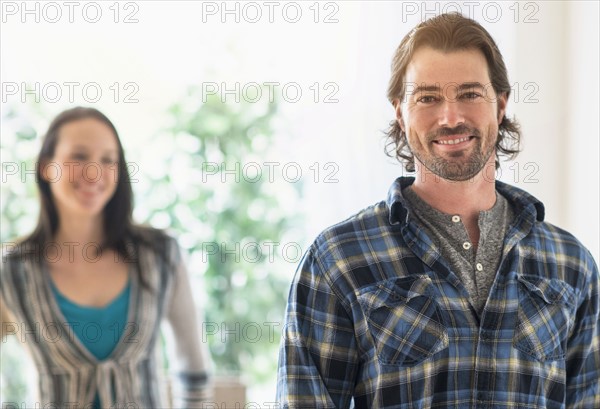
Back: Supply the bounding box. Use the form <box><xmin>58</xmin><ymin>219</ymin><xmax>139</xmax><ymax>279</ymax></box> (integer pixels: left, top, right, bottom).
<box><xmin>0</xmin><ymin>1</ymin><xmax>600</xmax><ymax>405</ymax></box>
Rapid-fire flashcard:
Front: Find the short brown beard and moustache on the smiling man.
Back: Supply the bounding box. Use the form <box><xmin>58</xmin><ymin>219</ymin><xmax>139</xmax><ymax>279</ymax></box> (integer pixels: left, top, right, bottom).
<box><xmin>413</xmin><ymin>125</ymin><xmax>497</xmax><ymax>182</ymax></box>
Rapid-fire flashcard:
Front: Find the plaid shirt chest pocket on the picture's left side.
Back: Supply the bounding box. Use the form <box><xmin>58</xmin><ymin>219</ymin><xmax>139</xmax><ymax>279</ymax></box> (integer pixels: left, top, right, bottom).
<box><xmin>359</xmin><ymin>275</ymin><xmax>448</xmax><ymax>367</ymax></box>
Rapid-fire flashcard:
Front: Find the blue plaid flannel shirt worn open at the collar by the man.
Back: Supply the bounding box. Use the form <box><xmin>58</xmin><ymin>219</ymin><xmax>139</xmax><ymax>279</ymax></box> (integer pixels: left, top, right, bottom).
<box><xmin>277</xmin><ymin>178</ymin><xmax>600</xmax><ymax>409</ymax></box>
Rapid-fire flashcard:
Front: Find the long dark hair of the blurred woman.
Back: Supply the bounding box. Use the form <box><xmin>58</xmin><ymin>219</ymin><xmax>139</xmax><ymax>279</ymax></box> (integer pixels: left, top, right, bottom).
<box><xmin>19</xmin><ymin>107</ymin><xmax>169</xmax><ymax>287</ymax></box>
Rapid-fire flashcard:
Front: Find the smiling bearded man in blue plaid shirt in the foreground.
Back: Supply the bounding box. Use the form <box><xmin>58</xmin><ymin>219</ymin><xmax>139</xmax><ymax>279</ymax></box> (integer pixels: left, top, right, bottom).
<box><xmin>277</xmin><ymin>14</ymin><xmax>600</xmax><ymax>409</ymax></box>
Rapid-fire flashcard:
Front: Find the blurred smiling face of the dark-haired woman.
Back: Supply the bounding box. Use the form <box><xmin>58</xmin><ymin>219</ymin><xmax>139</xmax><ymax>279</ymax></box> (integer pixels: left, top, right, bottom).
<box><xmin>42</xmin><ymin>118</ymin><xmax>119</xmax><ymax>216</ymax></box>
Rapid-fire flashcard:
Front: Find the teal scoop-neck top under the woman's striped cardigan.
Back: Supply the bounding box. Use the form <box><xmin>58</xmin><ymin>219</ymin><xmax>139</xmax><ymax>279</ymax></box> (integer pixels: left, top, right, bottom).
<box><xmin>50</xmin><ymin>280</ymin><xmax>131</xmax><ymax>409</ymax></box>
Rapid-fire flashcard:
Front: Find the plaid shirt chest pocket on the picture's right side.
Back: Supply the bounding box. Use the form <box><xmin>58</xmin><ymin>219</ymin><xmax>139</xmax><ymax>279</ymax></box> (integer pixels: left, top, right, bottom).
<box><xmin>513</xmin><ymin>275</ymin><xmax>575</xmax><ymax>362</ymax></box>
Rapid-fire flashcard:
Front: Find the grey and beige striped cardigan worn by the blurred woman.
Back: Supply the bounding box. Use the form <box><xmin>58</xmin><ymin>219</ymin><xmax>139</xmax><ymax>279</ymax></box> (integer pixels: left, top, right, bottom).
<box><xmin>0</xmin><ymin>234</ymin><xmax>208</xmax><ymax>408</ymax></box>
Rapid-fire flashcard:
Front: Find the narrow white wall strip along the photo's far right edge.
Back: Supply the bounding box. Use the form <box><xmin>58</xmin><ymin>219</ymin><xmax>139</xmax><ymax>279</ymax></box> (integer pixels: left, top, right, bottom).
<box><xmin>563</xmin><ymin>2</ymin><xmax>600</xmax><ymax>263</ymax></box>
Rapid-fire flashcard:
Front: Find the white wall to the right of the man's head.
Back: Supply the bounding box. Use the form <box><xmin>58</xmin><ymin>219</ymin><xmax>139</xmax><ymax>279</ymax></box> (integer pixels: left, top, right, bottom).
<box><xmin>507</xmin><ymin>1</ymin><xmax>599</xmax><ymax>260</ymax></box>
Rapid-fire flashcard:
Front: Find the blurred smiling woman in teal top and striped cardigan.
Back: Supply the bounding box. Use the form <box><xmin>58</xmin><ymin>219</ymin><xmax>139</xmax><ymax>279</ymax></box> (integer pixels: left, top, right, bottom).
<box><xmin>0</xmin><ymin>107</ymin><xmax>208</xmax><ymax>408</ymax></box>
